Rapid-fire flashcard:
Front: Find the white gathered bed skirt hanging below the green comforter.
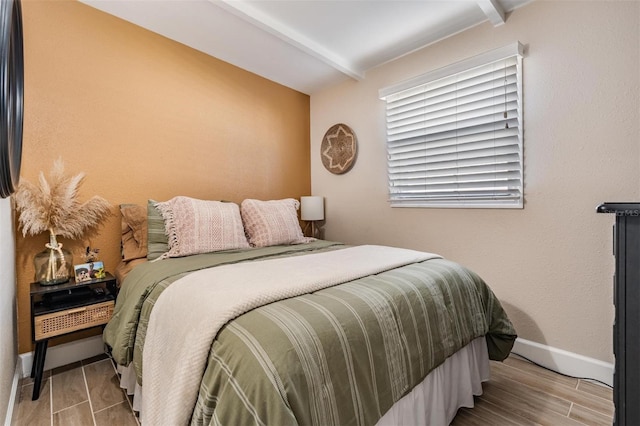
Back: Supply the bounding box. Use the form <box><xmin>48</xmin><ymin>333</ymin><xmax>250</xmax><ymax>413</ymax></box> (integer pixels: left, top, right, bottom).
<box><xmin>118</xmin><ymin>337</ymin><xmax>490</xmax><ymax>426</ymax></box>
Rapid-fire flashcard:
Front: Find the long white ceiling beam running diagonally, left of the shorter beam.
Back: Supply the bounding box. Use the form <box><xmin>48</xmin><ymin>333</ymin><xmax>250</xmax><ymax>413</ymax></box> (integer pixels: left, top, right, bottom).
<box><xmin>209</xmin><ymin>0</ymin><xmax>364</xmax><ymax>80</ymax></box>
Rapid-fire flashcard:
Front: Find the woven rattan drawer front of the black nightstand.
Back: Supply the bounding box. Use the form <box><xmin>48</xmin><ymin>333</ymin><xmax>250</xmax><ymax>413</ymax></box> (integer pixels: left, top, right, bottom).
<box><xmin>34</xmin><ymin>300</ymin><xmax>115</xmax><ymax>340</ymax></box>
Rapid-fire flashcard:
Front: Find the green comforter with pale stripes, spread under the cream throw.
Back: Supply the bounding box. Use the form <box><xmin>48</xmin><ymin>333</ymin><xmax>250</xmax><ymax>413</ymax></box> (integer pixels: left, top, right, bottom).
<box><xmin>105</xmin><ymin>242</ymin><xmax>515</xmax><ymax>425</ymax></box>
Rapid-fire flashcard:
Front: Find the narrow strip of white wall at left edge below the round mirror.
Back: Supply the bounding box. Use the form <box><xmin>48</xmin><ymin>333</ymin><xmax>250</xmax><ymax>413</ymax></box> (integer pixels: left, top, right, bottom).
<box><xmin>0</xmin><ymin>199</ymin><xmax>18</xmax><ymax>421</ymax></box>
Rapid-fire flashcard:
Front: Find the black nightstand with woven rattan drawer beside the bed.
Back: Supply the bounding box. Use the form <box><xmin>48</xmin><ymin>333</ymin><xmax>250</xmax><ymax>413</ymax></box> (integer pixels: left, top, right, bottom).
<box><xmin>30</xmin><ymin>272</ymin><xmax>118</xmax><ymax>401</ymax></box>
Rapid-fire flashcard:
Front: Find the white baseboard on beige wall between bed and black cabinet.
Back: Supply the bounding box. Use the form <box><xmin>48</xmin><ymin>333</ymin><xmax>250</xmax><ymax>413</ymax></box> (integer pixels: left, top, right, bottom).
<box><xmin>512</xmin><ymin>338</ymin><xmax>615</xmax><ymax>386</ymax></box>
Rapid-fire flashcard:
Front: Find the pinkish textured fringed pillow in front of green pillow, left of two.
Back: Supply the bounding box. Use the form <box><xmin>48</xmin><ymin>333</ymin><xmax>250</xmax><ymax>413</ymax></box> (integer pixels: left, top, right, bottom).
<box><xmin>156</xmin><ymin>196</ymin><xmax>249</xmax><ymax>258</ymax></box>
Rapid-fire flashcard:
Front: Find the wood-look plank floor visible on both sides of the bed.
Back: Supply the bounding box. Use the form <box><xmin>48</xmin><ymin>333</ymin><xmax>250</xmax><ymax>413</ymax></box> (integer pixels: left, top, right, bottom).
<box><xmin>12</xmin><ymin>356</ymin><xmax>613</xmax><ymax>426</ymax></box>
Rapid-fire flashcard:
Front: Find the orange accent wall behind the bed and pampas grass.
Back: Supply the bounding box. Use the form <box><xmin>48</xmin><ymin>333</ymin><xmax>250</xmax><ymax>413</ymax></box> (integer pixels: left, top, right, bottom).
<box><xmin>16</xmin><ymin>0</ymin><xmax>311</xmax><ymax>353</ymax></box>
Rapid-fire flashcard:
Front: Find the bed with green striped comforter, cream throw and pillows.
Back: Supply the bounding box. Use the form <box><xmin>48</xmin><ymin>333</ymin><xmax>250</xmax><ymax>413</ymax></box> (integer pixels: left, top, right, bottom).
<box><xmin>104</xmin><ymin>197</ymin><xmax>516</xmax><ymax>425</ymax></box>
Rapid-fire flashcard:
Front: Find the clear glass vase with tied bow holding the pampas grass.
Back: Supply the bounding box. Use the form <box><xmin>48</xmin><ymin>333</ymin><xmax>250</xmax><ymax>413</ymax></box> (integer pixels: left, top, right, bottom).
<box><xmin>33</xmin><ymin>234</ymin><xmax>73</xmax><ymax>285</ymax></box>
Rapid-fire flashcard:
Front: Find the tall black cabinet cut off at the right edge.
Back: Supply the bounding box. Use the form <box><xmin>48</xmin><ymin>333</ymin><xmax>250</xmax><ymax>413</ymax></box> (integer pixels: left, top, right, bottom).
<box><xmin>597</xmin><ymin>203</ymin><xmax>640</xmax><ymax>426</ymax></box>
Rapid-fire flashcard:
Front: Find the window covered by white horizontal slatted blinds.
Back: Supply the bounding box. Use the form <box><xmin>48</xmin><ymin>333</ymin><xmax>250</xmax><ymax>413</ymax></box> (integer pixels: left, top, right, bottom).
<box><xmin>380</xmin><ymin>43</ymin><xmax>524</xmax><ymax>208</ymax></box>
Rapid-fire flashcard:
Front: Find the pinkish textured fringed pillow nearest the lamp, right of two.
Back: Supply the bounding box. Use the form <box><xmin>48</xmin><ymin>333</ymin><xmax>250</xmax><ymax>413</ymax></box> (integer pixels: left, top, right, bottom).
<box><xmin>240</xmin><ymin>198</ymin><xmax>307</xmax><ymax>247</ymax></box>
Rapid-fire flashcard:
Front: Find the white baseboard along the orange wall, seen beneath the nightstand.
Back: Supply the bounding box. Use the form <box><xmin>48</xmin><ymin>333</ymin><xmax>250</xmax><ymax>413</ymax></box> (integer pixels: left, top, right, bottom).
<box><xmin>20</xmin><ymin>335</ymin><xmax>104</xmax><ymax>377</ymax></box>
